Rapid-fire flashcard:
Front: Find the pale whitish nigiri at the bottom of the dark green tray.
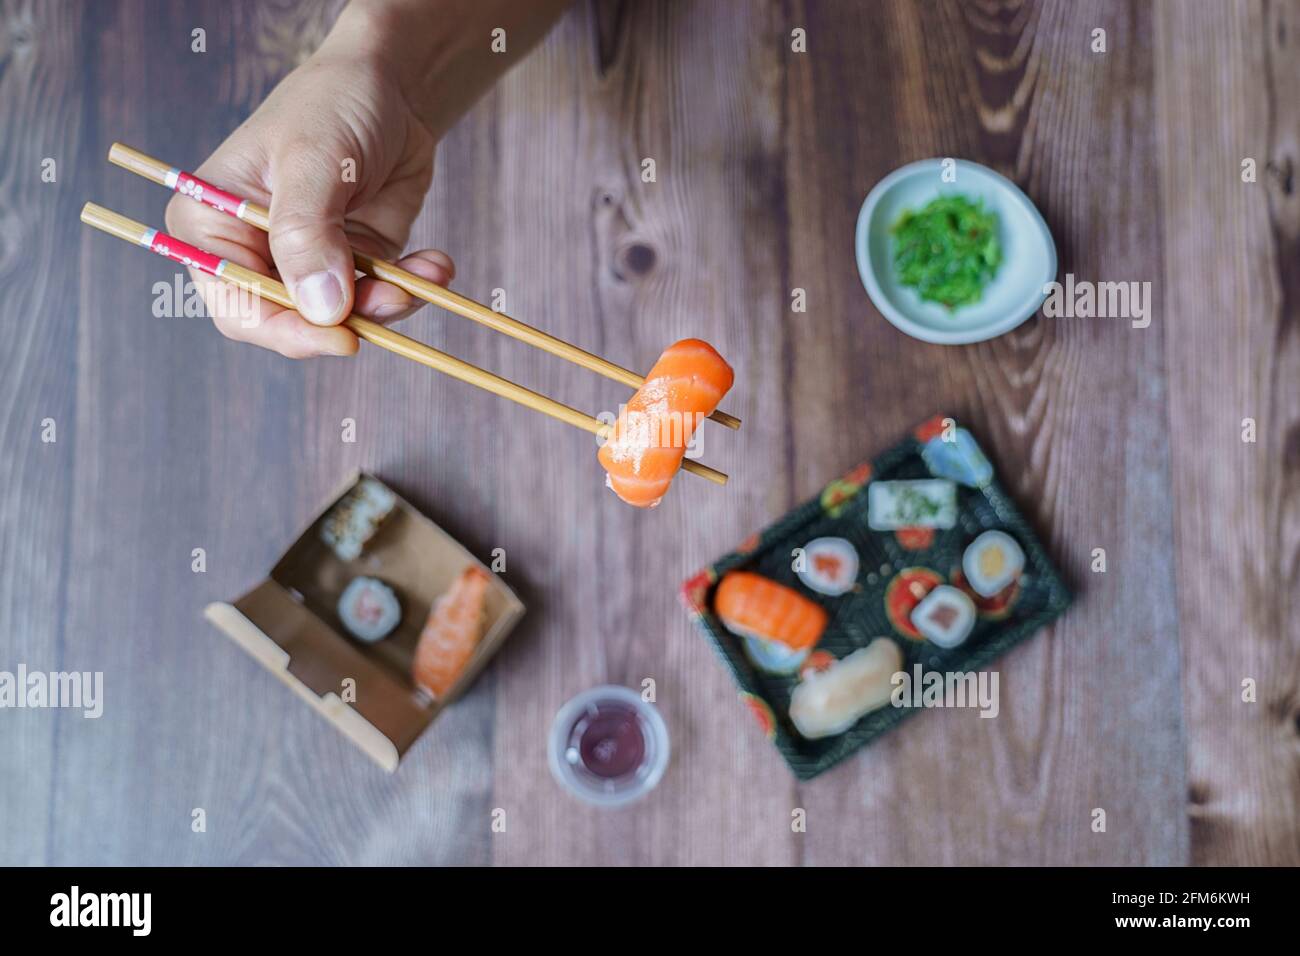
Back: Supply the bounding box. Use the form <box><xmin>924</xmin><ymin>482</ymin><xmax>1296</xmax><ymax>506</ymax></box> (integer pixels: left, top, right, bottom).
<box><xmin>790</xmin><ymin>637</ymin><xmax>902</xmax><ymax>740</ymax></box>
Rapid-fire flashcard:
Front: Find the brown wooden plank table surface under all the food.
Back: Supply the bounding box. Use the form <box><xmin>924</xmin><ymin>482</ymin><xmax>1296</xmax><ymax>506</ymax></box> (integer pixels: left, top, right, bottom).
<box><xmin>0</xmin><ymin>0</ymin><xmax>1300</xmax><ymax>865</ymax></box>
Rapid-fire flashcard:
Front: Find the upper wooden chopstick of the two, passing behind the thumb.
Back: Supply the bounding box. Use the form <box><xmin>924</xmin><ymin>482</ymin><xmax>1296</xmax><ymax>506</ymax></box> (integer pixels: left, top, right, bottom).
<box><xmin>108</xmin><ymin>143</ymin><xmax>740</xmax><ymax>428</ymax></box>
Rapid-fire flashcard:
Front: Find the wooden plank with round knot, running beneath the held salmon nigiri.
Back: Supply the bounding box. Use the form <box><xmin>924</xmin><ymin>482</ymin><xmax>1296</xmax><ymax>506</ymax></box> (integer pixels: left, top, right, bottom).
<box><xmin>486</xmin><ymin>4</ymin><xmax>793</xmax><ymax>864</ymax></box>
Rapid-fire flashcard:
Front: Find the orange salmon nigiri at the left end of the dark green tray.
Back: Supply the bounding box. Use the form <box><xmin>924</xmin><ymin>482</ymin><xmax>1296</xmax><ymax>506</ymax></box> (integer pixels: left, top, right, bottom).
<box><xmin>714</xmin><ymin>571</ymin><xmax>828</xmax><ymax>674</ymax></box>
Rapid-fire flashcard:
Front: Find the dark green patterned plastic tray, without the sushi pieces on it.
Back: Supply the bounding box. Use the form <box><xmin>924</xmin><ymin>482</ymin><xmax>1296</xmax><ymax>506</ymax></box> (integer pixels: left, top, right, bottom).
<box><xmin>681</xmin><ymin>416</ymin><xmax>1070</xmax><ymax>779</ymax></box>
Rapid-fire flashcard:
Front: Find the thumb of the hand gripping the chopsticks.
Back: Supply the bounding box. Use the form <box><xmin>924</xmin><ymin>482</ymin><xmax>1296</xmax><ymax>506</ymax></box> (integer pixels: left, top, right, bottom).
<box><xmin>270</xmin><ymin>148</ymin><xmax>355</xmax><ymax>325</ymax></box>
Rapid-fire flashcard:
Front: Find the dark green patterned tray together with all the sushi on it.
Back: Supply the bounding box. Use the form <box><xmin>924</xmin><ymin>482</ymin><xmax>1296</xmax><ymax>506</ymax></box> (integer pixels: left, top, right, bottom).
<box><xmin>683</xmin><ymin>416</ymin><xmax>1070</xmax><ymax>778</ymax></box>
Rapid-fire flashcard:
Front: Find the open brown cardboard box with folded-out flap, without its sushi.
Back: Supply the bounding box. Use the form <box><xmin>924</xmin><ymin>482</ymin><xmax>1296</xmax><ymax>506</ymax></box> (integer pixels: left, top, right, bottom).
<box><xmin>204</xmin><ymin>472</ymin><xmax>524</xmax><ymax>771</ymax></box>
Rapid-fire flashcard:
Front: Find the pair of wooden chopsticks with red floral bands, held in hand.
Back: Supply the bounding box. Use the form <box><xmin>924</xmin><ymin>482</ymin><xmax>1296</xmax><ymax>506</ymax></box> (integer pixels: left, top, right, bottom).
<box><xmin>81</xmin><ymin>143</ymin><xmax>740</xmax><ymax>485</ymax></box>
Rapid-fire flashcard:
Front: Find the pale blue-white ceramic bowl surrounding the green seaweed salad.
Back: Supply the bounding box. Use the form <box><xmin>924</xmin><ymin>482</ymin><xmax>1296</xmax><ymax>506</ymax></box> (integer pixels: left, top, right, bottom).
<box><xmin>854</xmin><ymin>159</ymin><xmax>1057</xmax><ymax>345</ymax></box>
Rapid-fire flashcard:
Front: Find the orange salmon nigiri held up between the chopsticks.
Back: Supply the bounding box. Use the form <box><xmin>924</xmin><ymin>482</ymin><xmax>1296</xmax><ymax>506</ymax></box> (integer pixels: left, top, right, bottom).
<box><xmin>598</xmin><ymin>338</ymin><xmax>736</xmax><ymax>507</ymax></box>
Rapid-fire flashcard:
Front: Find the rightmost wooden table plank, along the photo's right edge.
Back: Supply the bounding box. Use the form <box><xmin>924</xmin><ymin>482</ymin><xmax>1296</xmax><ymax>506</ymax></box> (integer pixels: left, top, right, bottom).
<box><xmin>1156</xmin><ymin>3</ymin><xmax>1300</xmax><ymax>866</ymax></box>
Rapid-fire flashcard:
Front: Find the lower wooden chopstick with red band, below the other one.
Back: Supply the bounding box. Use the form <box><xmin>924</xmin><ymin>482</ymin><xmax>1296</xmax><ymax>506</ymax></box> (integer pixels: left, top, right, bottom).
<box><xmin>81</xmin><ymin>203</ymin><xmax>727</xmax><ymax>485</ymax></box>
